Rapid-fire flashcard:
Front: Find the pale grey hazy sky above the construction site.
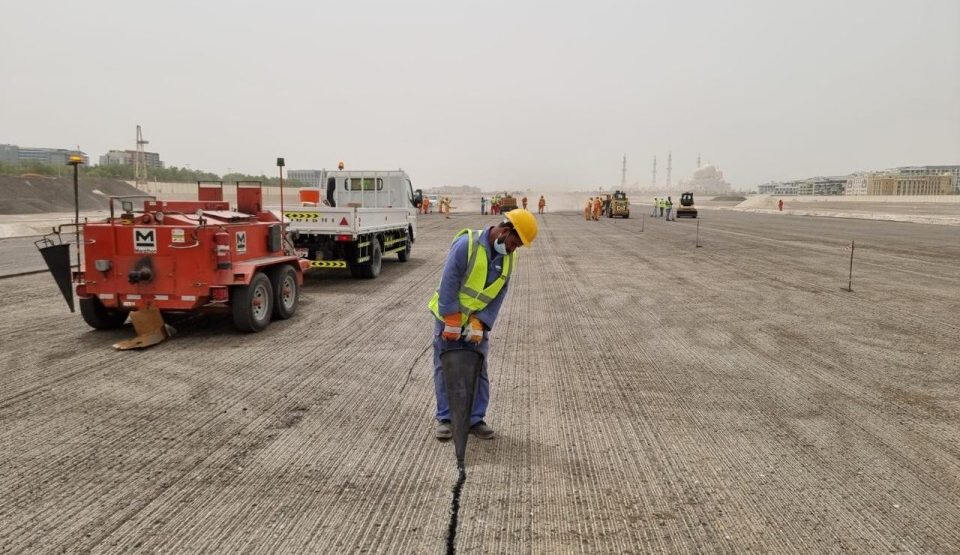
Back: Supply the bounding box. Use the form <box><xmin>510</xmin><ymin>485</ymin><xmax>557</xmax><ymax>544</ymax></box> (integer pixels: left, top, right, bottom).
<box><xmin>0</xmin><ymin>0</ymin><xmax>960</xmax><ymax>189</ymax></box>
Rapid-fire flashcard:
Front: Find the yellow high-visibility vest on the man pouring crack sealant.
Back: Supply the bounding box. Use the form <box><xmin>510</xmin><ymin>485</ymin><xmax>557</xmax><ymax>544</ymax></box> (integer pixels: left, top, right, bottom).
<box><xmin>427</xmin><ymin>229</ymin><xmax>514</xmax><ymax>327</ymax></box>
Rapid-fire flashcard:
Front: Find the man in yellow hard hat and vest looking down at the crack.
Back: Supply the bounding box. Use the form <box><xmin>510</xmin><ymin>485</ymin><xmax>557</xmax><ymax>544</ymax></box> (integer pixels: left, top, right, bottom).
<box><xmin>428</xmin><ymin>208</ymin><xmax>537</xmax><ymax>441</ymax></box>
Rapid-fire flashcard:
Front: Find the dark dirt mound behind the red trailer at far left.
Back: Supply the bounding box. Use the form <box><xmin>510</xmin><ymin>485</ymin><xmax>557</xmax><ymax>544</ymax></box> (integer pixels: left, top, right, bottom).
<box><xmin>0</xmin><ymin>175</ymin><xmax>142</xmax><ymax>214</ymax></box>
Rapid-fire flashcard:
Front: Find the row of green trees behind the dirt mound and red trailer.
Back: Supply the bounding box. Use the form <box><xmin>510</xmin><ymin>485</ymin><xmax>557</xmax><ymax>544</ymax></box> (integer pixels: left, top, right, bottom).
<box><xmin>0</xmin><ymin>162</ymin><xmax>302</xmax><ymax>187</ymax></box>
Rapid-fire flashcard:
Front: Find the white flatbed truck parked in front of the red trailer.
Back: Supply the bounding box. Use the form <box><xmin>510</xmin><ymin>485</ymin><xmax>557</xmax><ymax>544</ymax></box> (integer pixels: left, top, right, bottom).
<box><xmin>273</xmin><ymin>170</ymin><xmax>423</xmax><ymax>278</ymax></box>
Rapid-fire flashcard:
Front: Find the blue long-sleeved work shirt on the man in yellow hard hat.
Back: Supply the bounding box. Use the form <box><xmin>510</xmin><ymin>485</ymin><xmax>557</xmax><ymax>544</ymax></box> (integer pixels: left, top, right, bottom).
<box><xmin>436</xmin><ymin>227</ymin><xmax>510</xmax><ymax>330</ymax></box>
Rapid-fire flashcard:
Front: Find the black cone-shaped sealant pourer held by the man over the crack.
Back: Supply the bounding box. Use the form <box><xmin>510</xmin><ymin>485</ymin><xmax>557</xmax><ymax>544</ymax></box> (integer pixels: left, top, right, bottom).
<box><xmin>440</xmin><ymin>347</ymin><xmax>483</xmax><ymax>468</ymax></box>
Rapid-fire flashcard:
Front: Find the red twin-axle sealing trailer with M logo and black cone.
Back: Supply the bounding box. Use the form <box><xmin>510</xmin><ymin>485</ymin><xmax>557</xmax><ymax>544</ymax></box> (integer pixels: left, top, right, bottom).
<box><xmin>37</xmin><ymin>181</ymin><xmax>309</xmax><ymax>349</ymax></box>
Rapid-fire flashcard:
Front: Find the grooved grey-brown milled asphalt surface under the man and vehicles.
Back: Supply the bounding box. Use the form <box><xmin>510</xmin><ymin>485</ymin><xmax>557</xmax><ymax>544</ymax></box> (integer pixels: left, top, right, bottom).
<box><xmin>0</xmin><ymin>210</ymin><xmax>960</xmax><ymax>554</ymax></box>
